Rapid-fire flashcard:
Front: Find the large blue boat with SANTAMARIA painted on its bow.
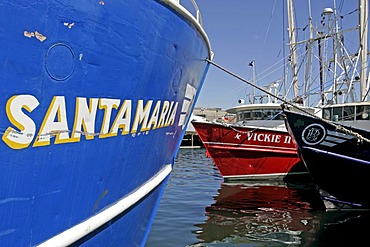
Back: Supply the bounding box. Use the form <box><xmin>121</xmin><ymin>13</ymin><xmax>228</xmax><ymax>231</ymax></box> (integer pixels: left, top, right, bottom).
<box><xmin>0</xmin><ymin>0</ymin><xmax>212</xmax><ymax>246</ymax></box>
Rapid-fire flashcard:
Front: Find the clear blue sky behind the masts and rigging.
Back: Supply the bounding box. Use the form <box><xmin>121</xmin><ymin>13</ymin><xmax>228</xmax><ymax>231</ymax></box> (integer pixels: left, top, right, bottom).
<box><xmin>185</xmin><ymin>0</ymin><xmax>358</xmax><ymax>109</ymax></box>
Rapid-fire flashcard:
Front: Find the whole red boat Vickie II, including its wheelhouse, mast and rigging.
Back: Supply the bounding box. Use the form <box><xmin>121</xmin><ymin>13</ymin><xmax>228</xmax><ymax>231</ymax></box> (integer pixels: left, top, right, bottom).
<box><xmin>192</xmin><ymin>1</ymin><xmax>330</xmax><ymax>180</ymax></box>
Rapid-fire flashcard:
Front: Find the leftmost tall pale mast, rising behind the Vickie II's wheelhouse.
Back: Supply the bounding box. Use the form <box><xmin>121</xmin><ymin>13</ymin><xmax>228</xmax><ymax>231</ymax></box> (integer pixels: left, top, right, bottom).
<box><xmin>287</xmin><ymin>0</ymin><xmax>298</xmax><ymax>97</ymax></box>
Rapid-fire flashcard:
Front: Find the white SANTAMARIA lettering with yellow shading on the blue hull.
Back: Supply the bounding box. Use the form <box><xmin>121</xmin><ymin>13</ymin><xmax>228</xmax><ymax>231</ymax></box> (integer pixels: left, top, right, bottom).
<box><xmin>2</xmin><ymin>95</ymin><xmax>189</xmax><ymax>149</ymax></box>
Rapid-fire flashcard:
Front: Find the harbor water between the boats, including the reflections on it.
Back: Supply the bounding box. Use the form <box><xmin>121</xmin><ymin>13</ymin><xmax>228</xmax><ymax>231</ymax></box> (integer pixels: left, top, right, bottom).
<box><xmin>146</xmin><ymin>148</ymin><xmax>370</xmax><ymax>247</ymax></box>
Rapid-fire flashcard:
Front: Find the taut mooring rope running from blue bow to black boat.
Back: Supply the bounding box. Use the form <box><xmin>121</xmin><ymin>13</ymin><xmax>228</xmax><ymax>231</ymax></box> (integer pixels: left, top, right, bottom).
<box><xmin>206</xmin><ymin>59</ymin><xmax>370</xmax><ymax>143</ymax></box>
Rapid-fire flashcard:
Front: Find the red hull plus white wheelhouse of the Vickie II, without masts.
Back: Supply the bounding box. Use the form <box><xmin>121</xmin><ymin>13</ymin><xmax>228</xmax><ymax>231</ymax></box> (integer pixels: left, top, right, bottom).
<box><xmin>192</xmin><ymin>103</ymin><xmax>307</xmax><ymax>180</ymax></box>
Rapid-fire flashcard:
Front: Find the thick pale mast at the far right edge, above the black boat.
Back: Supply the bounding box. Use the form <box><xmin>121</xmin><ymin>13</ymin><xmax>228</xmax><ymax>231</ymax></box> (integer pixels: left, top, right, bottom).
<box><xmin>358</xmin><ymin>0</ymin><xmax>368</xmax><ymax>101</ymax></box>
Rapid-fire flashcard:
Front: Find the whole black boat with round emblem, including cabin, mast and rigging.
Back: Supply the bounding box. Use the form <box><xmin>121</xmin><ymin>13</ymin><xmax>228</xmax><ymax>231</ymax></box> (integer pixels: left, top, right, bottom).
<box><xmin>284</xmin><ymin>0</ymin><xmax>370</xmax><ymax>210</ymax></box>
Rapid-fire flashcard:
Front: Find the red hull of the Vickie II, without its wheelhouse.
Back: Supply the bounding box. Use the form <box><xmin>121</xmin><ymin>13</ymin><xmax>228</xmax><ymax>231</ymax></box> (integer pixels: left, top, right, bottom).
<box><xmin>192</xmin><ymin>122</ymin><xmax>308</xmax><ymax>180</ymax></box>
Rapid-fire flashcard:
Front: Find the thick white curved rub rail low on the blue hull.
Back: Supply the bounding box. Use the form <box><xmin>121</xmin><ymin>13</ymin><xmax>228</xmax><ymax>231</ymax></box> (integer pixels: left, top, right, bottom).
<box><xmin>38</xmin><ymin>164</ymin><xmax>172</xmax><ymax>247</ymax></box>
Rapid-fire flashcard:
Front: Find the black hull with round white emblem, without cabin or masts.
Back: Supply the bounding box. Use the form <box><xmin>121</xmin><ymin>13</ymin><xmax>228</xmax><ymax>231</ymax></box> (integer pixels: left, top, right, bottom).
<box><xmin>284</xmin><ymin>110</ymin><xmax>370</xmax><ymax>209</ymax></box>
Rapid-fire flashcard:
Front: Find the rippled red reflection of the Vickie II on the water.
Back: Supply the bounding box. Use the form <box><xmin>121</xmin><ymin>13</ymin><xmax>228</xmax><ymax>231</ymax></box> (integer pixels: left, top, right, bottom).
<box><xmin>193</xmin><ymin>182</ymin><xmax>323</xmax><ymax>246</ymax></box>
